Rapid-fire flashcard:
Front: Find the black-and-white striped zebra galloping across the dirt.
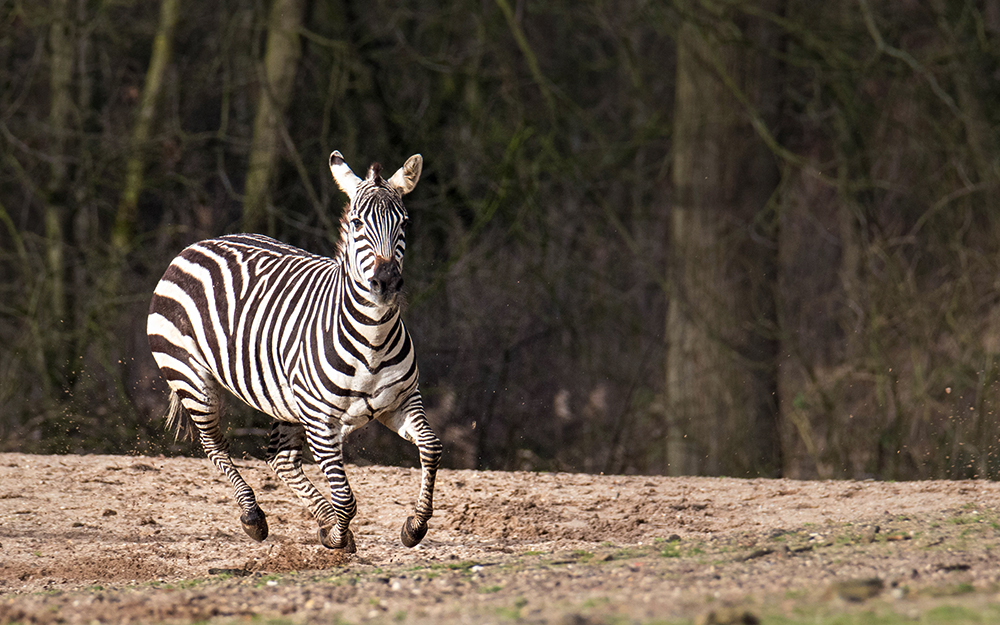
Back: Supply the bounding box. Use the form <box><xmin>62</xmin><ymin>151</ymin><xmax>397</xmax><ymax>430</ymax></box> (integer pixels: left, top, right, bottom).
<box><xmin>147</xmin><ymin>151</ymin><xmax>442</xmax><ymax>553</ymax></box>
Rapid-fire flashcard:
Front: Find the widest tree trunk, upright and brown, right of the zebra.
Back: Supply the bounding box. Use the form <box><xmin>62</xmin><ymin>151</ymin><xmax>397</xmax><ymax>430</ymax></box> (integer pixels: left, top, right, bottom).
<box><xmin>666</xmin><ymin>1</ymin><xmax>782</xmax><ymax>476</ymax></box>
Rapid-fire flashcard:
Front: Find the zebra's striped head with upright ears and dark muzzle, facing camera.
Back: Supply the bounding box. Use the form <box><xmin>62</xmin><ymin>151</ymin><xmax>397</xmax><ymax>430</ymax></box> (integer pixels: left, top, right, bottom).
<box><xmin>330</xmin><ymin>152</ymin><xmax>424</xmax><ymax>305</ymax></box>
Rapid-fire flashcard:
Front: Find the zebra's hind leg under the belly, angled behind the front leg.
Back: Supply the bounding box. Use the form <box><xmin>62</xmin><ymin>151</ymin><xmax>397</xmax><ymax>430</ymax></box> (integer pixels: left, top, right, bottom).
<box><xmin>267</xmin><ymin>421</ymin><xmax>357</xmax><ymax>553</ymax></box>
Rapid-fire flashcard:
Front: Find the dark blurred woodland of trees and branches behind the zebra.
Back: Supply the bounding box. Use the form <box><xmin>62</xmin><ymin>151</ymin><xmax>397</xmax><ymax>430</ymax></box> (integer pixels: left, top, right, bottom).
<box><xmin>0</xmin><ymin>0</ymin><xmax>1000</xmax><ymax>479</ymax></box>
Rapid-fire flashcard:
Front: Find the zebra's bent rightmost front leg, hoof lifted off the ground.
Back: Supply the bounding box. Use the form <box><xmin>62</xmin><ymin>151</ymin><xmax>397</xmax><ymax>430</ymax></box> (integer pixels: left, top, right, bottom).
<box><xmin>379</xmin><ymin>391</ymin><xmax>441</xmax><ymax>547</ymax></box>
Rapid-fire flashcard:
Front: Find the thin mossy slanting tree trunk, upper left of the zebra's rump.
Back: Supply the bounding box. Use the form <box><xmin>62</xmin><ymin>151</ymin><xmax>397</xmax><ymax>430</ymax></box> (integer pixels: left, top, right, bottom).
<box><xmin>111</xmin><ymin>0</ymin><xmax>180</xmax><ymax>255</ymax></box>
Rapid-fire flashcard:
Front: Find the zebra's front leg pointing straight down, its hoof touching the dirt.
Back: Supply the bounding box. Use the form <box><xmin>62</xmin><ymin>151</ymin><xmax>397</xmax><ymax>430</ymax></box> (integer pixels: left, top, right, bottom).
<box><xmin>305</xmin><ymin>423</ymin><xmax>358</xmax><ymax>553</ymax></box>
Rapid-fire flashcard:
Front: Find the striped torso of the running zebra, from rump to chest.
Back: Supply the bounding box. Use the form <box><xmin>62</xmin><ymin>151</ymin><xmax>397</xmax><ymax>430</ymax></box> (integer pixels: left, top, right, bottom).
<box><xmin>148</xmin><ymin>235</ymin><xmax>417</xmax><ymax>425</ymax></box>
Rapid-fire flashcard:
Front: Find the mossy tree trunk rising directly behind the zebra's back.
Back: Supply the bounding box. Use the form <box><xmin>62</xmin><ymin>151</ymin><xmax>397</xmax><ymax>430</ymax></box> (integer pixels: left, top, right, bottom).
<box><xmin>243</xmin><ymin>0</ymin><xmax>305</xmax><ymax>233</ymax></box>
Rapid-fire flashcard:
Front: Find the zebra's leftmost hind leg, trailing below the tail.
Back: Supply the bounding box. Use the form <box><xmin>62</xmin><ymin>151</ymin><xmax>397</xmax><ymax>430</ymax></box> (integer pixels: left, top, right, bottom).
<box><xmin>175</xmin><ymin>384</ymin><xmax>268</xmax><ymax>542</ymax></box>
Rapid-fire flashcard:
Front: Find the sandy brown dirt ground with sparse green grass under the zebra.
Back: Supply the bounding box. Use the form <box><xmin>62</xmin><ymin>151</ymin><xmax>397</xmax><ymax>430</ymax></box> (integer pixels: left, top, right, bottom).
<box><xmin>0</xmin><ymin>454</ymin><xmax>1000</xmax><ymax>625</ymax></box>
